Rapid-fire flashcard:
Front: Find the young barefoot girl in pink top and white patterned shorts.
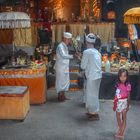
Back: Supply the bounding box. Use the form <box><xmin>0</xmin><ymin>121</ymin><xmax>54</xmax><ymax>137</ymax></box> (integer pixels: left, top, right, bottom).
<box><xmin>113</xmin><ymin>69</ymin><xmax>131</xmax><ymax>138</ymax></box>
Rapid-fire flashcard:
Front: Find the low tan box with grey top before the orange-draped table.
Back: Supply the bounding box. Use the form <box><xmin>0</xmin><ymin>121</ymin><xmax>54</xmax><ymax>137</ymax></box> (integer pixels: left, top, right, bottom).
<box><xmin>0</xmin><ymin>86</ymin><xmax>30</xmax><ymax>120</ymax></box>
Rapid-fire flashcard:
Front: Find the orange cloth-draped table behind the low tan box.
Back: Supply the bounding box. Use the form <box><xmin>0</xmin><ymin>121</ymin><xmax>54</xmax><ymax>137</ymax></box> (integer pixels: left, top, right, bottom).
<box><xmin>0</xmin><ymin>67</ymin><xmax>46</xmax><ymax>104</ymax></box>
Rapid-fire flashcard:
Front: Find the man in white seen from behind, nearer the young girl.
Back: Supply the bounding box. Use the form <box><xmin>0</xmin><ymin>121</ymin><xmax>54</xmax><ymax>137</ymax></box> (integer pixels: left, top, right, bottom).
<box><xmin>81</xmin><ymin>33</ymin><xmax>102</xmax><ymax>120</ymax></box>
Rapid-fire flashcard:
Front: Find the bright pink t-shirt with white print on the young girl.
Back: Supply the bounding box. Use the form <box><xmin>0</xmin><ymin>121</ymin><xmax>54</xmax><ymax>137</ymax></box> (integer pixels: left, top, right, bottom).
<box><xmin>116</xmin><ymin>83</ymin><xmax>131</xmax><ymax>99</ymax></box>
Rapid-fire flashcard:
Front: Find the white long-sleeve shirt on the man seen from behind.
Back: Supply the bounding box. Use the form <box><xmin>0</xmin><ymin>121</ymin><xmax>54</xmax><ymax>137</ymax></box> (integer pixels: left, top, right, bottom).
<box><xmin>81</xmin><ymin>48</ymin><xmax>102</xmax><ymax>80</ymax></box>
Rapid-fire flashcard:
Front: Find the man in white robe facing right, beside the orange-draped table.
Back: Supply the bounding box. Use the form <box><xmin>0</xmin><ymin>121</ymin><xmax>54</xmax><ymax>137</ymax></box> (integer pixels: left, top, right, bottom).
<box><xmin>55</xmin><ymin>32</ymin><xmax>73</xmax><ymax>101</ymax></box>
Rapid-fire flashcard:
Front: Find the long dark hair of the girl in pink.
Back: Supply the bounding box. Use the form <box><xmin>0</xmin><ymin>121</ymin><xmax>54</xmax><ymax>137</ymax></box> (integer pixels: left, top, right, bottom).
<box><xmin>116</xmin><ymin>68</ymin><xmax>129</xmax><ymax>86</ymax></box>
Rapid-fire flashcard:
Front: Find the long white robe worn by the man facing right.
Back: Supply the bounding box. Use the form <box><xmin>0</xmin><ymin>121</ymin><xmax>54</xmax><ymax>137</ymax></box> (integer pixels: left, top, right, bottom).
<box><xmin>55</xmin><ymin>42</ymin><xmax>73</xmax><ymax>93</ymax></box>
